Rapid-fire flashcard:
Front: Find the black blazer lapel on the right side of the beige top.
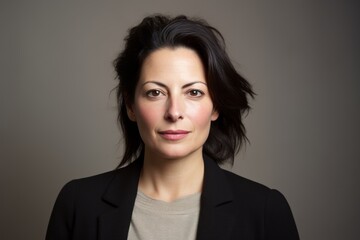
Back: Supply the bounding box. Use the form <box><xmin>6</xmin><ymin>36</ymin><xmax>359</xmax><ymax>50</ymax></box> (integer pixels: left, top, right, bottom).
<box><xmin>197</xmin><ymin>156</ymin><xmax>236</xmax><ymax>240</ymax></box>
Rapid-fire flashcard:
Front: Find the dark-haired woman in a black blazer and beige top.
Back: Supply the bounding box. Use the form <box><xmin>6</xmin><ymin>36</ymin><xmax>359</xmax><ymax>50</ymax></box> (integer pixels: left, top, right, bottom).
<box><xmin>46</xmin><ymin>15</ymin><xmax>299</xmax><ymax>240</ymax></box>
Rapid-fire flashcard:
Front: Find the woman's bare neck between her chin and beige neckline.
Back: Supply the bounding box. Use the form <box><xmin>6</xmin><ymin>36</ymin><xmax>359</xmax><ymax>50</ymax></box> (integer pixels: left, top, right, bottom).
<box><xmin>139</xmin><ymin>151</ymin><xmax>204</xmax><ymax>202</ymax></box>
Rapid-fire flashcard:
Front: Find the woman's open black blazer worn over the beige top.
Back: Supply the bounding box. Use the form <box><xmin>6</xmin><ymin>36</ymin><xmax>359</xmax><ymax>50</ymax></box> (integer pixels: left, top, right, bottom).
<box><xmin>46</xmin><ymin>157</ymin><xmax>299</xmax><ymax>240</ymax></box>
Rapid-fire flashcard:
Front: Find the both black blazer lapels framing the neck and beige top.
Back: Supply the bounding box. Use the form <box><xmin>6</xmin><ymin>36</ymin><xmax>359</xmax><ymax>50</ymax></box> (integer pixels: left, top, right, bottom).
<box><xmin>99</xmin><ymin>156</ymin><xmax>236</xmax><ymax>240</ymax></box>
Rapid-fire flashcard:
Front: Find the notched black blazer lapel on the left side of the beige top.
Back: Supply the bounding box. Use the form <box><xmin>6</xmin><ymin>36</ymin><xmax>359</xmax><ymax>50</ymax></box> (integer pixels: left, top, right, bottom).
<box><xmin>98</xmin><ymin>159</ymin><xmax>142</xmax><ymax>240</ymax></box>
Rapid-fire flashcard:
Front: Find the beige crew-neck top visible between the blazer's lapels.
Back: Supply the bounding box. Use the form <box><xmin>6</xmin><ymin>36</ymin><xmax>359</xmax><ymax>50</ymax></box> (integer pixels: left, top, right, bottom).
<box><xmin>128</xmin><ymin>190</ymin><xmax>201</xmax><ymax>240</ymax></box>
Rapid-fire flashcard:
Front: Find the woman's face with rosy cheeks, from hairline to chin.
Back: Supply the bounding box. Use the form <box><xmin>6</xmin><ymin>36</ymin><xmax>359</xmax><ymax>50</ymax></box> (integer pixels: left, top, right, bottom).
<box><xmin>128</xmin><ymin>47</ymin><xmax>218</xmax><ymax>158</ymax></box>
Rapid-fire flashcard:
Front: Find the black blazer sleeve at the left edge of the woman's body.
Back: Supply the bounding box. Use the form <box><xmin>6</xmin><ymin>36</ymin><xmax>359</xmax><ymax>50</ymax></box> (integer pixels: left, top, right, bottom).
<box><xmin>45</xmin><ymin>182</ymin><xmax>76</xmax><ymax>240</ymax></box>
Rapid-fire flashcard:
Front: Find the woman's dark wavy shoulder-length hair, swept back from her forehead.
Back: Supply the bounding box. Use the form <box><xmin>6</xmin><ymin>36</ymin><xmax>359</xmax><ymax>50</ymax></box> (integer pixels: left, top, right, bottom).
<box><xmin>114</xmin><ymin>15</ymin><xmax>255</xmax><ymax>167</ymax></box>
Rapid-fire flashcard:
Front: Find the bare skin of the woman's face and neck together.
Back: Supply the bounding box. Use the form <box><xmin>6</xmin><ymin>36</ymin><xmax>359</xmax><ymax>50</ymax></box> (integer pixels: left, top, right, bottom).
<box><xmin>128</xmin><ymin>47</ymin><xmax>218</xmax><ymax>201</ymax></box>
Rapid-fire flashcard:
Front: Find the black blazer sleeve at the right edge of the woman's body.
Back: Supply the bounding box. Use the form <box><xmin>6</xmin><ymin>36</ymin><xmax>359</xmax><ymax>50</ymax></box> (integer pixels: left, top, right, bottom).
<box><xmin>265</xmin><ymin>190</ymin><xmax>300</xmax><ymax>240</ymax></box>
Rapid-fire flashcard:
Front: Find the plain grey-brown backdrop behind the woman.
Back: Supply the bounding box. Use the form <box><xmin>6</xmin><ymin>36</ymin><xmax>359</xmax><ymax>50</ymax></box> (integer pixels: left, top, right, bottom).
<box><xmin>0</xmin><ymin>0</ymin><xmax>360</xmax><ymax>240</ymax></box>
